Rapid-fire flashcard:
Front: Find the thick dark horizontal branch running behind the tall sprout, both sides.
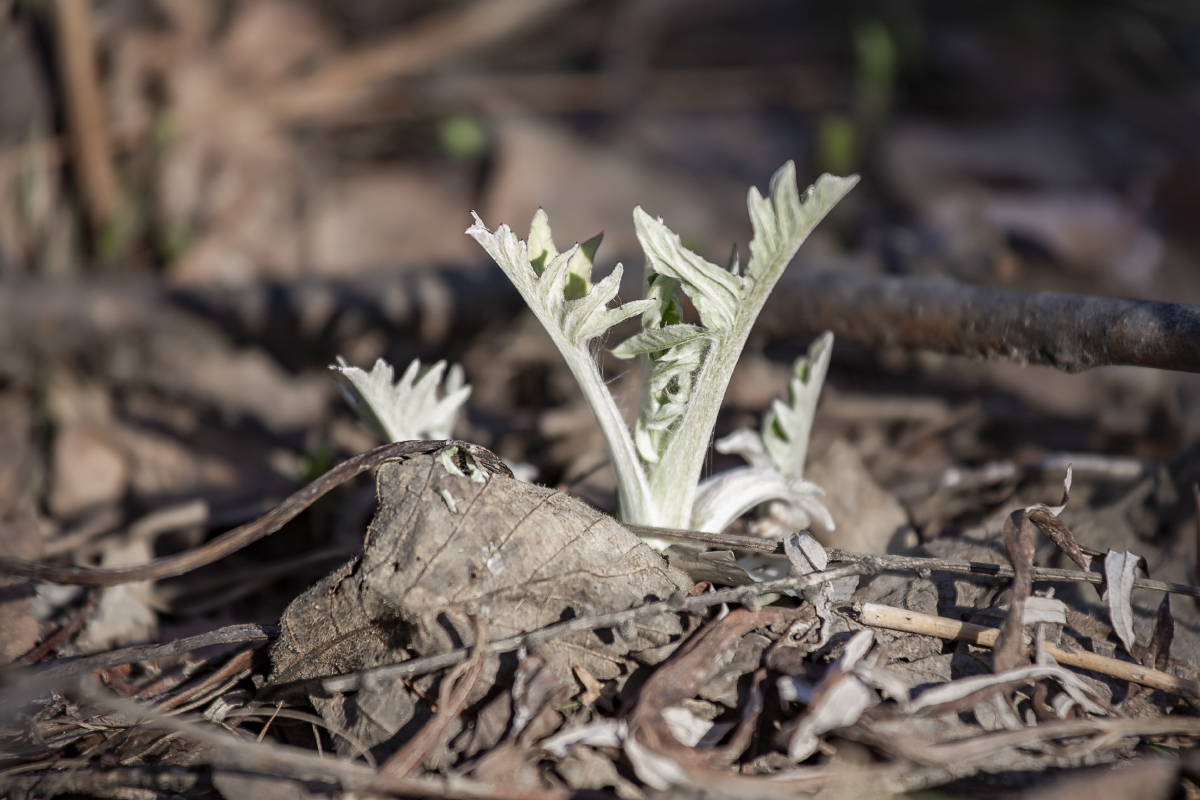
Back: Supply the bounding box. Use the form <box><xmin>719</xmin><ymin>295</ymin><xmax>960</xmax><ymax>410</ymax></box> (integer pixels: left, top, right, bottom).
<box><xmin>0</xmin><ymin>267</ymin><xmax>1200</xmax><ymax>372</ymax></box>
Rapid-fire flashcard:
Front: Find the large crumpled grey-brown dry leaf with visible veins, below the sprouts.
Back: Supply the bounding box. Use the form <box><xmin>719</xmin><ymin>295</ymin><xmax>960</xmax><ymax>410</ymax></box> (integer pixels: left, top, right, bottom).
<box><xmin>271</xmin><ymin>456</ymin><xmax>689</xmax><ymax>746</ymax></box>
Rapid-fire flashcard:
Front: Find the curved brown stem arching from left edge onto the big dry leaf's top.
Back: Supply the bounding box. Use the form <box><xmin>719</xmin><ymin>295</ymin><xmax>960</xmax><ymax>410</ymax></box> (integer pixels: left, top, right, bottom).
<box><xmin>0</xmin><ymin>440</ymin><xmax>512</xmax><ymax>587</ymax></box>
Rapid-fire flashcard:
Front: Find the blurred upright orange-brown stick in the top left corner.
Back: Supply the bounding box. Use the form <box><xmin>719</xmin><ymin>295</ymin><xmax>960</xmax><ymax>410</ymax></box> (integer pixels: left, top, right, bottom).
<box><xmin>53</xmin><ymin>0</ymin><xmax>121</xmax><ymax>231</ymax></box>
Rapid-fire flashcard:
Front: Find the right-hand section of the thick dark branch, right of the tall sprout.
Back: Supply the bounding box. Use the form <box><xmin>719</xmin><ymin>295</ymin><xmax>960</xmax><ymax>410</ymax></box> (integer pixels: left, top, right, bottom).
<box><xmin>763</xmin><ymin>271</ymin><xmax>1200</xmax><ymax>372</ymax></box>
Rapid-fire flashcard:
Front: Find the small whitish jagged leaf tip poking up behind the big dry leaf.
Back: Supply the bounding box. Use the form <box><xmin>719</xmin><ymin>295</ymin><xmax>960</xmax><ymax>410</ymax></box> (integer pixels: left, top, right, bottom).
<box><xmin>330</xmin><ymin>356</ymin><xmax>470</xmax><ymax>441</ymax></box>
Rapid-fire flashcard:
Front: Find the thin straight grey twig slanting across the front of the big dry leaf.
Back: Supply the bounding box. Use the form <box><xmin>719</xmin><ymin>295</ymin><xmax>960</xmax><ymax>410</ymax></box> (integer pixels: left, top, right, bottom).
<box><xmin>304</xmin><ymin>560</ymin><xmax>878</xmax><ymax>699</ymax></box>
